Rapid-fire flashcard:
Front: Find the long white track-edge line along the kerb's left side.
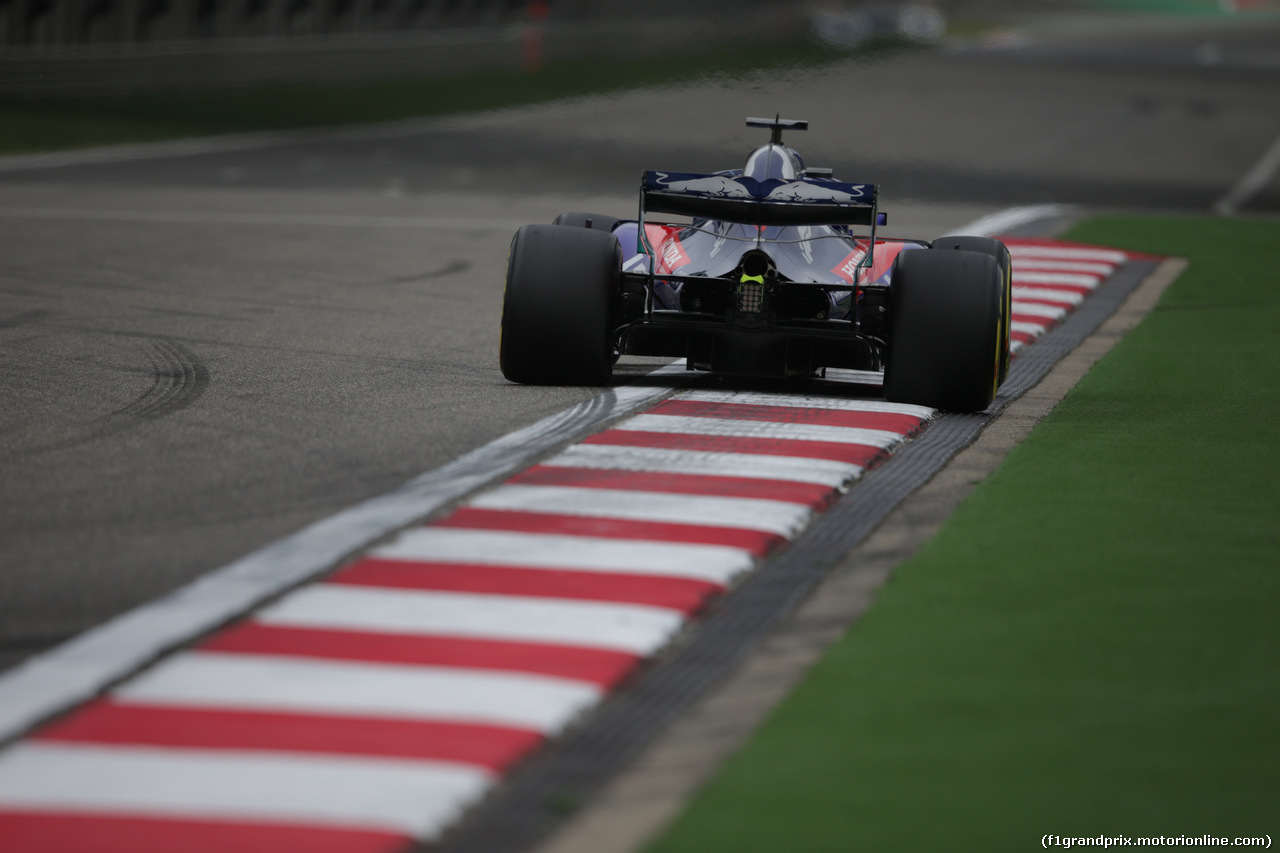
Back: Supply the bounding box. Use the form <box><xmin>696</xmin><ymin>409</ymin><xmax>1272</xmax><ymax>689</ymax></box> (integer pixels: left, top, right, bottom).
<box><xmin>0</xmin><ymin>365</ymin><xmax>684</xmax><ymax>740</ymax></box>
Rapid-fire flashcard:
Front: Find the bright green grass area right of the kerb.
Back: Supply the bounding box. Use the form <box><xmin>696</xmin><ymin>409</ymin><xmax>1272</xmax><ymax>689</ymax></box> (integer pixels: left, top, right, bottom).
<box><xmin>649</xmin><ymin>218</ymin><xmax>1280</xmax><ymax>853</ymax></box>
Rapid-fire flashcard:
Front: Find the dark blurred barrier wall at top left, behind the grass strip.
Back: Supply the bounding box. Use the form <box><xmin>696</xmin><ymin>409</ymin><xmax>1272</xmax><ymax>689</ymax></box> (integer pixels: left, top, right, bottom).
<box><xmin>0</xmin><ymin>0</ymin><xmax>796</xmax><ymax>97</ymax></box>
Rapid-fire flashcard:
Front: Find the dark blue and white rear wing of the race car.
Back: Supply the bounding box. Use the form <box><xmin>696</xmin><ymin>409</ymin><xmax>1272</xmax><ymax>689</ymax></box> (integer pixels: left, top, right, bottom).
<box><xmin>640</xmin><ymin>172</ymin><xmax>881</xmax><ymax>229</ymax></box>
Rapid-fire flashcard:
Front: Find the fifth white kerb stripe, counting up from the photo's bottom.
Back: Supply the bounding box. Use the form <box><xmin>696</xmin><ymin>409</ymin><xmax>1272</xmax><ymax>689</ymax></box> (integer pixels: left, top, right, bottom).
<box><xmin>471</xmin><ymin>485</ymin><xmax>813</xmax><ymax>538</ymax></box>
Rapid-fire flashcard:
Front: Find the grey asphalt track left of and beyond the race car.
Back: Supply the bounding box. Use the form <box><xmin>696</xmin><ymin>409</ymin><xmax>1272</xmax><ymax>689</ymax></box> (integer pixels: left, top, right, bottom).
<box><xmin>0</xmin><ymin>11</ymin><xmax>1280</xmax><ymax>845</ymax></box>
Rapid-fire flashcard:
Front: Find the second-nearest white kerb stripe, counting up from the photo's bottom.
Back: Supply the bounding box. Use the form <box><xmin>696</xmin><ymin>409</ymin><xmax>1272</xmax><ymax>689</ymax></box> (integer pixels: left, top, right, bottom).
<box><xmin>113</xmin><ymin>652</ymin><xmax>602</xmax><ymax>733</ymax></box>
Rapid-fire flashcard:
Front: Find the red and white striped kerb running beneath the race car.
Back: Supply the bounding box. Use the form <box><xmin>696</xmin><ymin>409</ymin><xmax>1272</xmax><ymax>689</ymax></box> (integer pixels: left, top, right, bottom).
<box><xmin>0</xmin><ymin>234</ymin><xmax>1141</xmax><ymax>853</ymax></box>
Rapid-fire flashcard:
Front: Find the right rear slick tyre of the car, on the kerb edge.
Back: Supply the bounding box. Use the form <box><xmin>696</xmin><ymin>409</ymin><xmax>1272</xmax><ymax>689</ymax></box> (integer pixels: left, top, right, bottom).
<box><xmin>884</xmin><ymin>248</ymin><xmax>1005</xmax><ymax>411</ymax></box>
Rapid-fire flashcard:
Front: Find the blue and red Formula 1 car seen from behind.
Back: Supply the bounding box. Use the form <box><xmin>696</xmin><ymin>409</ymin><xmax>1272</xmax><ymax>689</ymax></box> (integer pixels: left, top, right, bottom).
<box><xmin>499</xmin><ymin>118</ymin><xmax>1011</xmax><ymax>411</ymax></box>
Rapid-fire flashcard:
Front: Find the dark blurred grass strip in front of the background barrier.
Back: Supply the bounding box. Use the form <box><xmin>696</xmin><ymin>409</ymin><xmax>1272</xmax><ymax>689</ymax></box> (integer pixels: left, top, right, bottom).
<box><xmin>0</xmin><ymin>41</ymin><xmax>875</xmax><ymax>155</ymax></box>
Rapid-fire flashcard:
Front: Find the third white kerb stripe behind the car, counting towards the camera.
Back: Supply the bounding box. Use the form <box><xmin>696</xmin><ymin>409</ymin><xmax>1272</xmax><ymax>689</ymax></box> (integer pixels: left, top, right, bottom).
<box><xmin>541</xmin><ymin>444</ymin><xmax>863</xmax><ymax>488</ymax></box>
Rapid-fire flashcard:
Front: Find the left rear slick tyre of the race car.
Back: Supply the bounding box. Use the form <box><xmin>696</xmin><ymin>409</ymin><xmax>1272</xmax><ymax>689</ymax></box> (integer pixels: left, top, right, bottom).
<box><xmin>498</xmin><ymin>225</ymin><xmax>622</xmax><ymax>386</ymax></box>
